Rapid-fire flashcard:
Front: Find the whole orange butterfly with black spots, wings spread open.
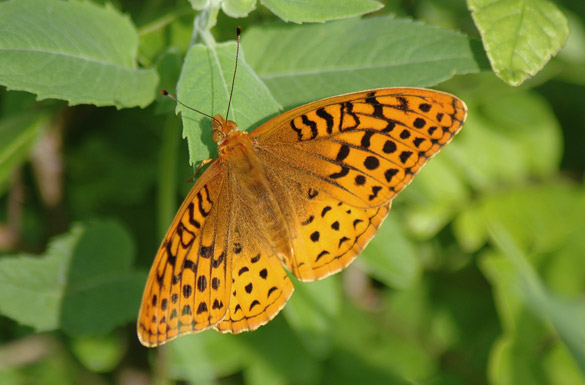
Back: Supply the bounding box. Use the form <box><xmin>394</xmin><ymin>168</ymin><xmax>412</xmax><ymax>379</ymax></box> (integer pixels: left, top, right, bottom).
<box><xmin>138</xmin><ymin>88</ymin><xmax>467</xmax><ymax>347</ymax></box>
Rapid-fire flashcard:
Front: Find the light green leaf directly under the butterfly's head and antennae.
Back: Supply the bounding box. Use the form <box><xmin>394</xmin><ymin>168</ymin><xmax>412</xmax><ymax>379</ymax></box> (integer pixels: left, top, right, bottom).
<box><xmin>177</xmin><ymin>43</ymin><xmax>280</xmax><ymax>164</ymax></box>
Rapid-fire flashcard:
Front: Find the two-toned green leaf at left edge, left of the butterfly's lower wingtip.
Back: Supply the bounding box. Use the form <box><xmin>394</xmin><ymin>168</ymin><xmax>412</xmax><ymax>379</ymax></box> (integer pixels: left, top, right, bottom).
<box><xmin>0</xmin><ymin>222</ymin><xmax>146</xmax><ymax>335</ymax></box>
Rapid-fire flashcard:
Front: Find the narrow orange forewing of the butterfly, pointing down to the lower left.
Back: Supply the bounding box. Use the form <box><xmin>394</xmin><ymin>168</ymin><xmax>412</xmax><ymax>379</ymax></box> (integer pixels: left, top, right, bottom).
<box><xmin>138</xmin><ymin>161</ymin><xmax>232</xmax><ymax>347</ymax></box>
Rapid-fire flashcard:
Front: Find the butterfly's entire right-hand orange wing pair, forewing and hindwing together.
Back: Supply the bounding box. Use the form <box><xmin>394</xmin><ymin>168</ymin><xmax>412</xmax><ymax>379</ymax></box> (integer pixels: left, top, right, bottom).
<box><xmin>250</xmin><ymin>88</ymin><xmax>467</xmax><ymax>280</ymax></box>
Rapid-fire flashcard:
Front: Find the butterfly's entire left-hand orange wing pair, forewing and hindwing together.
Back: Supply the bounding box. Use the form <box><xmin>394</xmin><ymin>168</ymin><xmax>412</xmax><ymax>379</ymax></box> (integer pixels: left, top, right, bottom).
<box><xmin>137</xmin><ymin>161</ymin><xmax>293</xmax><ymax>347</ymax></box>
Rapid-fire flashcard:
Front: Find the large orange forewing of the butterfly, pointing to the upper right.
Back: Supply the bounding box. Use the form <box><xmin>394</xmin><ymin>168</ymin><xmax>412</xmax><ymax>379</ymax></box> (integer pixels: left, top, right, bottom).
<box><xmin>251</xmin><ymin>88</ymin><xmax>467</xmax><ymax>208</ymax></box>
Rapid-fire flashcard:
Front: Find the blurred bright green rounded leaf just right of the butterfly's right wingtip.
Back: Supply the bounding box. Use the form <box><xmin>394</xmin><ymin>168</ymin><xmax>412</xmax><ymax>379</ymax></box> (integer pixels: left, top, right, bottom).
<box><xmin>447</xmin><ymin>92</ymin><xmax>562</xmax><ymax>190</ymax></box>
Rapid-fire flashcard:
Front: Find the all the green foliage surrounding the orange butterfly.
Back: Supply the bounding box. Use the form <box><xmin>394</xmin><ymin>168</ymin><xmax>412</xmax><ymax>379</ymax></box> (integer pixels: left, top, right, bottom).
<box><xmin>0</xmin><ymin>0</ymin><xmax>585</xmax><ymax>385</ymax></box>
